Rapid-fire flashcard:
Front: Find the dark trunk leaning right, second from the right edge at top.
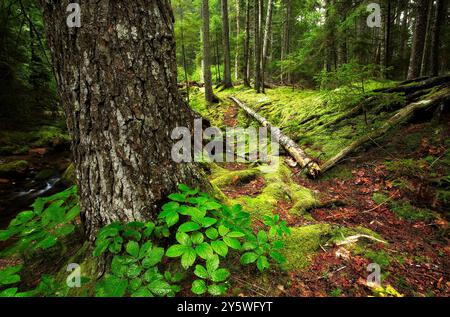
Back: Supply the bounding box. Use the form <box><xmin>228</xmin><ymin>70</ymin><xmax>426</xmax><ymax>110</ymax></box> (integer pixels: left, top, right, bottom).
<box><xmin>408</xmin><ymin>0</ymin><xmax>428</xmax><ymax>79</ymax></box>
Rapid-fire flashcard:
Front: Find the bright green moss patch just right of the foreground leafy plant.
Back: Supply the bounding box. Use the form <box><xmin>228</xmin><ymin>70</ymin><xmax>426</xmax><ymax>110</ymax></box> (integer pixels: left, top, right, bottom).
<box><xmin>282</xmin><ymin>224</ymin><xmax>332</xmax><ymax>270</ymax></box>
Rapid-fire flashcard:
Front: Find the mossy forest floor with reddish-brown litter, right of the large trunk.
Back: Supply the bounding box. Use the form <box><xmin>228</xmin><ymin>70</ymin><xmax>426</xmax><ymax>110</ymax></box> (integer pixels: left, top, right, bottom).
<box><xmin>194</xmin><ymin>84</ymin><xmax>450</xmax><ymax>296</ymax></box>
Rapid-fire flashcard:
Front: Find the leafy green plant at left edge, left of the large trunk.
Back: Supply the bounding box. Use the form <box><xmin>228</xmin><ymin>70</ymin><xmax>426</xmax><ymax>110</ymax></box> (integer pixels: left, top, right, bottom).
<box><xmin>0</xmin><ymin>186</ymin><xmax>80</xmax><ymax>256</ymax></box>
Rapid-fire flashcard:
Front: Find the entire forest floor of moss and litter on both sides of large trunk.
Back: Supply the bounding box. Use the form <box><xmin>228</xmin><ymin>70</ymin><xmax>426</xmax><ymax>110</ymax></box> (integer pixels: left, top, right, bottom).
<box><xmin>0</xmin><ymin>82</ymin><xmax>450</xmax><ymax>296</ymax></box>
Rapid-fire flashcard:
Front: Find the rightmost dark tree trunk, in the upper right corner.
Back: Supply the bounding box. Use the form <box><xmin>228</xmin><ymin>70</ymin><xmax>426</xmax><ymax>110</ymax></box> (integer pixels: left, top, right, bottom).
<box><xmin>430</xmin><ymin>0</ymin><xmax>448</xmax><ymax>76</ymax></box>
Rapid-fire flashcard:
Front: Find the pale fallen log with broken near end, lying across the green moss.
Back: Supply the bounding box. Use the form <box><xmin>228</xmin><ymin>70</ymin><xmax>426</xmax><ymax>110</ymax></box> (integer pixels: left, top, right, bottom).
<box><xmin>230</xmin><ymin>97</ymin><xmax>321</xmax><ymax>178</ymax></box>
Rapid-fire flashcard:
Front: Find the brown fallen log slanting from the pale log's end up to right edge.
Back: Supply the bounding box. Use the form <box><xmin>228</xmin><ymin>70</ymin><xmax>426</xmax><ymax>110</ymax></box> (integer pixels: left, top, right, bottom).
<box><xmin>321</xmin><ymin>88</ymin><xmax>450</xmax><ymax>173</ymax></box>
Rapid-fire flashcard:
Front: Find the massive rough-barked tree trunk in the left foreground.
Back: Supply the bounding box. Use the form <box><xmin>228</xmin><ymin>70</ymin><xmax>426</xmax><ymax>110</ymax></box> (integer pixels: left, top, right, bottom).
<box><xmin>41</xmin><ymin>0</ymin><xmax>205</xmax><ymax>240</ymax></box>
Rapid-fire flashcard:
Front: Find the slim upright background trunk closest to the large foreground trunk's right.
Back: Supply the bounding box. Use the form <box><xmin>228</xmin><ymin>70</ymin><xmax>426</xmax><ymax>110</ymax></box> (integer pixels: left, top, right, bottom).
<box><xmin>202</xmin><ymin>0</ymin><xmax>217</xmax><ymax>102</ymax></box>
